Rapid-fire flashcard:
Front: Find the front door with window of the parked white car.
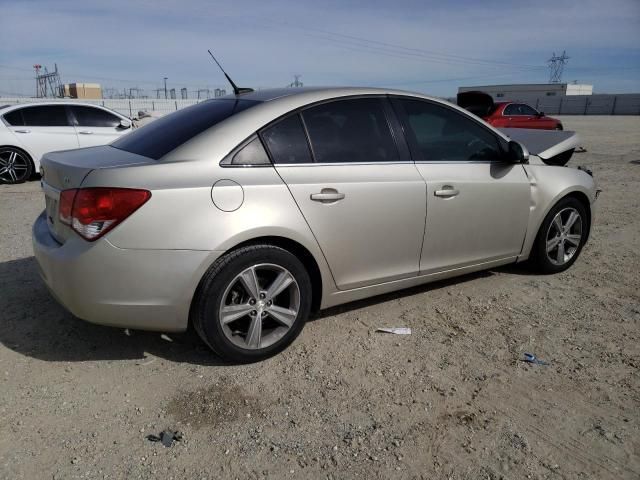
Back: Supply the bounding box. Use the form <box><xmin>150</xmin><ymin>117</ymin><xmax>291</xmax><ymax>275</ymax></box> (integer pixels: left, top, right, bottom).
<box><xmin>70</xmin><ymin>105</ymin><xmax>130</xmax><ymax>147</ymax></box>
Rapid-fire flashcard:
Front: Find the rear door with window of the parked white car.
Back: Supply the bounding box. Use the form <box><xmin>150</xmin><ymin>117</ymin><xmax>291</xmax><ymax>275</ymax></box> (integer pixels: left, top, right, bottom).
<box><xmin>5</xmin><ymin>105</ymin><xmax>78</xmax><ymax>162</ymax></box>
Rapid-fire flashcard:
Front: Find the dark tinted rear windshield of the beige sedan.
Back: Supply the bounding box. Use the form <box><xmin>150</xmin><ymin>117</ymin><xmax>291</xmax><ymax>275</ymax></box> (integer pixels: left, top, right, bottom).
<box><xmin>111</xmin><ymin>98</ymin><xmax>260</xmax><ymax>160</ymax></box>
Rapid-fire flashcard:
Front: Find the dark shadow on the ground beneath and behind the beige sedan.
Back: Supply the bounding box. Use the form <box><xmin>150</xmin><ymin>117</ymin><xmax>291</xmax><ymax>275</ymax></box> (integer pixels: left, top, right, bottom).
<box><xmin>0</xmin><ymin>257</ymin><xmax>527</xmax><ymax>366</ymax></box>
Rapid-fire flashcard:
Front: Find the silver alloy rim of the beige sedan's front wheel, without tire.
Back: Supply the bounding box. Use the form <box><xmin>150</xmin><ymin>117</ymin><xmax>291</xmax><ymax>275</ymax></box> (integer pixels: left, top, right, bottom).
<box><xmin>546</xmin><ymin>207</ymin><xmax>582</xmax><ymax>265</ymax></box>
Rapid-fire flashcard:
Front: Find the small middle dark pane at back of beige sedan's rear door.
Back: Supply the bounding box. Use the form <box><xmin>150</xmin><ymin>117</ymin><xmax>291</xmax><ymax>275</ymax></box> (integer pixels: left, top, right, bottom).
<box><xmin>261</xmin><ymin>115</ymin><xmax>313</xmax><ymax>163</ymax></box>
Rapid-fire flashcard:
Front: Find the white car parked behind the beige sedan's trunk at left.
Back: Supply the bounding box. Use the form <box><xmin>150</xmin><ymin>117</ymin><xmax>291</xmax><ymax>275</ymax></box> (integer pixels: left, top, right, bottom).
<box><xmin>0</xmin><ymin>102</ymin><xmax>132</xmax><ymax>183</ymax></box>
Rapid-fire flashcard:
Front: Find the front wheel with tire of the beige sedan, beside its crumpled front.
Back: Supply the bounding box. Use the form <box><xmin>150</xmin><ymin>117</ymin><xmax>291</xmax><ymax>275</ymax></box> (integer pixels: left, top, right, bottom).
<box><xmin>531</xmin><ymin>197</ymin><xmax>590</xmax><ymax>273</ymax></box>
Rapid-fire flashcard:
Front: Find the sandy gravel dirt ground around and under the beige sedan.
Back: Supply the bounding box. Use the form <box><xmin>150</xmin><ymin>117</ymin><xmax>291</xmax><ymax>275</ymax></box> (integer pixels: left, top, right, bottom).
<box><xmin>0</xmin><ymin>117</ymin><xmax>640</xmax><ymax>480</ymax></box>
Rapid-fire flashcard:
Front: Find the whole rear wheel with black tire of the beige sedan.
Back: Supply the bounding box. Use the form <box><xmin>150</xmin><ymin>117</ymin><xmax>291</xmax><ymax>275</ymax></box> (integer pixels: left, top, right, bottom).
<box><xmin>192</xmin><ymin>245</ymin><xmax>312</xmax><ymax>363</ymax></box>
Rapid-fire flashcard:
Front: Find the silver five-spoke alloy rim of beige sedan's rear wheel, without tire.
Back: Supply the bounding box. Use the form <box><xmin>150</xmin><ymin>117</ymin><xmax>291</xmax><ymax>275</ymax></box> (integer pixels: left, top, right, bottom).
<box><xmin>218</xmin><ymin>263</ymin><xmax>300</xmax><ymax>350</ymax></box>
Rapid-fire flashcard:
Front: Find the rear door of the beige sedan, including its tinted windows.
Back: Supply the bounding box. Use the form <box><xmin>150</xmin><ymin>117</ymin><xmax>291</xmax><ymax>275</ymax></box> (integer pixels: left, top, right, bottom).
<box><xmin>261</xmin><ymin>97</ymin><xmax>426</xmax><ymax>290</ymax></box>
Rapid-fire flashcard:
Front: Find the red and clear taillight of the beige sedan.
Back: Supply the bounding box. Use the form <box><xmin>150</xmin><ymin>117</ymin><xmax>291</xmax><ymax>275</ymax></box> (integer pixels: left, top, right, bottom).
<box><xmin>58</xmin><ymin>187</ymin><xmax>151</xmax><ymax>241</ymax></box>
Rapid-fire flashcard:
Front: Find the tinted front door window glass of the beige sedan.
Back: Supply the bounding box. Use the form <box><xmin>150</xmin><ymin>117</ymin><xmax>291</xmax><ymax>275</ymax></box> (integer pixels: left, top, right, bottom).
<box><xmin>397</xmin><ymin>99</ymin><xmax>502</xmax><ymax>161</ymax></box>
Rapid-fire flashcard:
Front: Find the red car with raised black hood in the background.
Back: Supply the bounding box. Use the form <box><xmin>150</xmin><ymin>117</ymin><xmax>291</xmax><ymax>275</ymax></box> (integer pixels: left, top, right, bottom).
<box><xmin>458</xmin><ymin>92</ymin><xmax>562</xmax><ymax>130</ymax></box>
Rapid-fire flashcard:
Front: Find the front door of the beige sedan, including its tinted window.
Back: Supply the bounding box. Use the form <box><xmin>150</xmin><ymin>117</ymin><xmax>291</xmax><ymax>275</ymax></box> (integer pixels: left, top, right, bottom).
<box><xmin>393</xmin><ymin>98</ymin><xmax>531</xmax><ymax>274</ymax></box>
